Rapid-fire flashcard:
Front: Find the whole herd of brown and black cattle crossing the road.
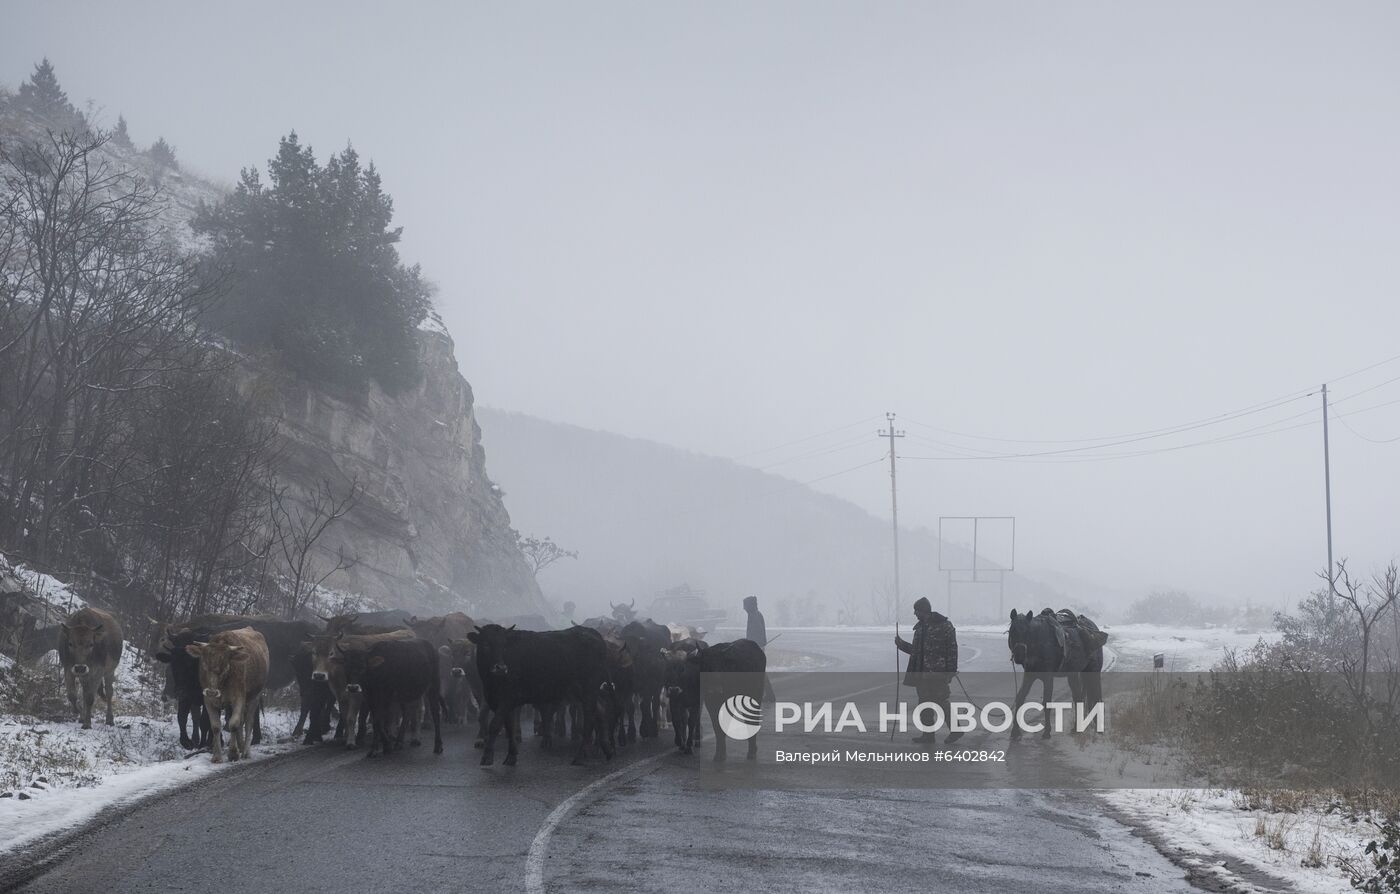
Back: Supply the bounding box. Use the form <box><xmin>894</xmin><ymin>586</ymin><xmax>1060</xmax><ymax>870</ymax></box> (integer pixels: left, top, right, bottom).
<box><xmin>38</xmin><ymin>606</ymin><xmax>766</xmax><ymax>765</ymax></box>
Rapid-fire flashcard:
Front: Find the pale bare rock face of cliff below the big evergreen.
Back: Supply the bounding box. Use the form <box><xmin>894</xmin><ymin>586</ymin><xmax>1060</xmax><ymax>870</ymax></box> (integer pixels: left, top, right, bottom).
<box><xmin>242</xmin><ymin>323</ymin><xmax>545</xmax><ymax>616</ymax></box>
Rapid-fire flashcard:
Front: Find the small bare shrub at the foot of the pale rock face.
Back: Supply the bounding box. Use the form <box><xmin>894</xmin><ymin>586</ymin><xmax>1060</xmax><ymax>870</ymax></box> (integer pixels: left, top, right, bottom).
<box><xmin>269</xmin><ymin>478</ymin><xmax>364</xmax><ymax>618</ymax></box>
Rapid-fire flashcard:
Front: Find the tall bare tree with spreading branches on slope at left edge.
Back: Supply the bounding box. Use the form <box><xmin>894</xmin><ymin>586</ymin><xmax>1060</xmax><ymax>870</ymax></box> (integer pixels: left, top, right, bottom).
<box><xmin>0</xmin><ymin>133</ymin><xmax>217</xmax><ymax>562</ymax></box>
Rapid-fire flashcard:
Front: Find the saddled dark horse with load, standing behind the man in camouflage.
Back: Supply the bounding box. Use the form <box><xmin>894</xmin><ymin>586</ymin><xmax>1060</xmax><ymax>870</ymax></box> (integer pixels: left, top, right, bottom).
<box><xmin>1007</xmin><ymin>609</ymin><xmax>1109</xmax><ymax>742</ymax></box>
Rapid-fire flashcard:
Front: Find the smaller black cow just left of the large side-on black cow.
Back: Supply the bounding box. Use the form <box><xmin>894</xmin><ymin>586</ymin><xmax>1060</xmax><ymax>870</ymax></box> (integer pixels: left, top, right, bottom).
<box><xmin>336</xmin><ymin>639</ymin><xmax>442</xmax><ymax>757</ymax></box>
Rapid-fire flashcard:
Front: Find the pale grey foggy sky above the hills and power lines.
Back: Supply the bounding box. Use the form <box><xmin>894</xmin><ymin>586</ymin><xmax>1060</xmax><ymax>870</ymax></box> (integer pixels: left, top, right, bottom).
<box><xmin>0</xmin><ymin>3</ymin><xmax>1400</xmax><ymax>602</ymax></box>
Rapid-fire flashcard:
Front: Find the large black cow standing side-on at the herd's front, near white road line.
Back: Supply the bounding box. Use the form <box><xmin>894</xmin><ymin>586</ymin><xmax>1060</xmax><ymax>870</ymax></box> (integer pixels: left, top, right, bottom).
<box><xmin>468</xmin><ymin>624</ymin><xmax>613</xmax><ymax>767</ymax></box>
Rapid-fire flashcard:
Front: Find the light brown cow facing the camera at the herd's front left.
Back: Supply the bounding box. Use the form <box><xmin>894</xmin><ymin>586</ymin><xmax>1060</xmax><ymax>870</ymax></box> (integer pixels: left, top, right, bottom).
<box><xmin>185</xmin><ymin>627</ymin><xmax>267</xmax><ymax>764</ymax></box>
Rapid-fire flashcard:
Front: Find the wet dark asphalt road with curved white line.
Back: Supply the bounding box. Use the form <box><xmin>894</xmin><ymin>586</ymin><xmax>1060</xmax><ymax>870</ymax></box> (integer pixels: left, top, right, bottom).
<box><xmin>5</xmin><ymin>631</ymin><xmax>1190</xmax><ymax>894</ymax></box>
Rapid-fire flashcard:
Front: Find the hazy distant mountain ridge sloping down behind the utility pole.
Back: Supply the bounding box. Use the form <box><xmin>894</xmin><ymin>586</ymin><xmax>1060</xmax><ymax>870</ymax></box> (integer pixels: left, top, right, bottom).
<box><xmin>476</xmin><ymin>407</ymin><xmax>1064</xmax><ymax>624</ymax></box>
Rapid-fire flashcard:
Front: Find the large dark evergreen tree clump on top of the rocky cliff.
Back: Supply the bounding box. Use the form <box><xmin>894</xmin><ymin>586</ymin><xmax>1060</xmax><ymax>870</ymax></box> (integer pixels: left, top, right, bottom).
<box><xmin>195</xmin><ymin>132</ymin><xmax>428</xmax><ymax>392</ymax></box>
